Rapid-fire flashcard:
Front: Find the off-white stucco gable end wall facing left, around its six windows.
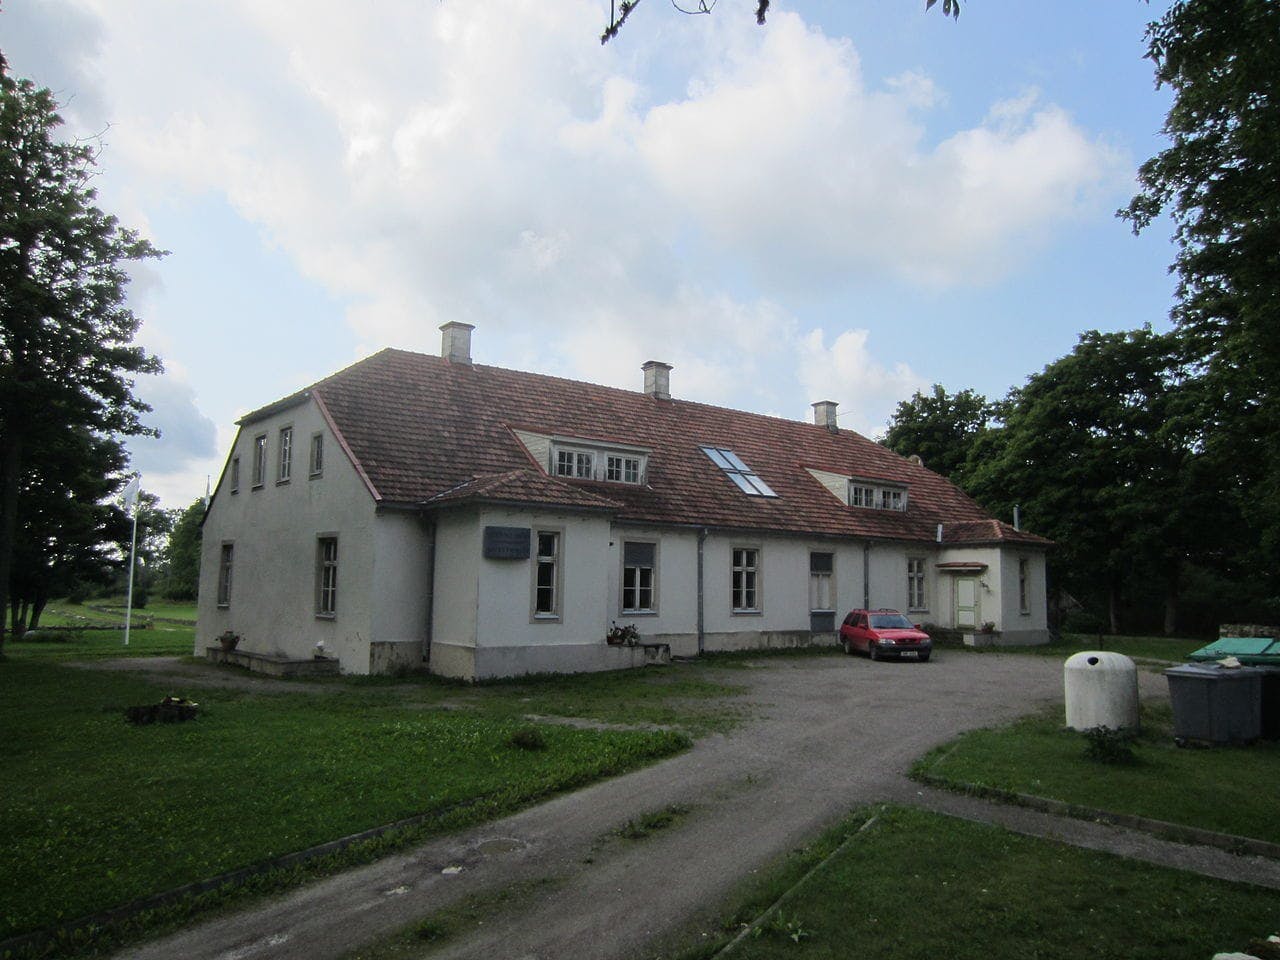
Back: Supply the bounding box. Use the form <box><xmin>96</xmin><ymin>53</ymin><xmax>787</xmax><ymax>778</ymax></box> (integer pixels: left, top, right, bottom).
<box><xmin>196</xmin><ymin>401</ymin><xmax>375</xmax><ymax>673</ymax></box>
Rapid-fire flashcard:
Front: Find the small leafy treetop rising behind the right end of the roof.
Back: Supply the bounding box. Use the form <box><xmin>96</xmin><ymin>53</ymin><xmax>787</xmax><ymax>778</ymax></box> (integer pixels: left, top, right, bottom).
<box><xmin>881</xmin><ymin>384</ymin><xmax>996</xmax><ymax>485</ymax></box>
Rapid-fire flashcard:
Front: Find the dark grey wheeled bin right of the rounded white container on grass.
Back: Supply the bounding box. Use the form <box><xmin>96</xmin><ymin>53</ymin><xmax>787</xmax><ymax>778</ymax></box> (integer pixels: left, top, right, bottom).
<box><xmin>1165</xmin><ymin>663</ymin><xmax>1263</xmax><ymax>744</ymax></box>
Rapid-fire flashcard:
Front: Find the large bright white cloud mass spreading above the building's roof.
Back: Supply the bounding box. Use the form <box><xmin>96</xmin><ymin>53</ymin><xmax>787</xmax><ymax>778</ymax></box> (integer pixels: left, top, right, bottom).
<box><xmin>7</xmin><ymin>0</ymin><xmax>1128</xmax><ymax>506</ymax></box>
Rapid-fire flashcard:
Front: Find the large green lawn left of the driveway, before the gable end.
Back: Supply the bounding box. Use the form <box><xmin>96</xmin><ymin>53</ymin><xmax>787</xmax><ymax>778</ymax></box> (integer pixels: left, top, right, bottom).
<box><xmin>0</xmin><ymin>655</ymin><xmax>739</xmax><ymax>940</ymax></box>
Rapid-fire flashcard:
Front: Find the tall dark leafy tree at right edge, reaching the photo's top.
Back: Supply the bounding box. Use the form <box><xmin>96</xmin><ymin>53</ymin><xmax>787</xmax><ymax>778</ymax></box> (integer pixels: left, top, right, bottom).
<box><xmin>1120</xmin><ymin>0</ymin><xmax>1280</xmax><ymax>571</ymax></box>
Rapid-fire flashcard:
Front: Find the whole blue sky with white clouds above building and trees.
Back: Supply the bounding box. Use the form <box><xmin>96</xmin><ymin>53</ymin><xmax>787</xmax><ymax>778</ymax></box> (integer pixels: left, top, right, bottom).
<box><xmin>0</xmin><ymin>0</ymin><xmax>1174</xmax><ymax>506</ymax></box>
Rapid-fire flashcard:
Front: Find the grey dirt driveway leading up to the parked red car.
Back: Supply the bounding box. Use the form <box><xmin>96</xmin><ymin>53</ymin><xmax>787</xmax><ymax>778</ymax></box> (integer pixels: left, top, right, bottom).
<box><xmin>117</xmin><ymin>652</ymin><xmax>1187</xmax><ymax>960</ymax></box>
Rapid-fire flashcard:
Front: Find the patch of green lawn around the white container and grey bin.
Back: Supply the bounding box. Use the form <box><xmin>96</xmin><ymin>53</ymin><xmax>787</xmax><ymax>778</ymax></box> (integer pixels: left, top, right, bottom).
<box><xmin>913</xmin><ymin>703</ymin><xmax>1280</xmax><ymax>844</ymax></box>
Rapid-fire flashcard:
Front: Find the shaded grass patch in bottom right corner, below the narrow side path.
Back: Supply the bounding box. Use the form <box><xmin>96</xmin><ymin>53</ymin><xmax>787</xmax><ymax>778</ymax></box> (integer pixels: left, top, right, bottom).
<box><xmin>678</xmin><ymin>808</ymin><xmax>1280</xmax><ymax>960</ymax></box>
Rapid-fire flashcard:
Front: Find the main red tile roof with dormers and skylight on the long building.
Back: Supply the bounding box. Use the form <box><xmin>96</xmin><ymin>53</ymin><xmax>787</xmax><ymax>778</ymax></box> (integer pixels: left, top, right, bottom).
<box><xmin>242</xmin><ymin>349</ymin><xmax>1048</xmax><ymax>544</ymax></box>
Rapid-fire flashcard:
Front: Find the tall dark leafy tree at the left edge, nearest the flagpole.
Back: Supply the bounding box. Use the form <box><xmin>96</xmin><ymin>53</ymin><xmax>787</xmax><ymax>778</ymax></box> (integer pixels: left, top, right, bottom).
<box><xmin>0</xmin><ymin>56</ymin><xmax>160</xmax><ymax>655</ymax></box>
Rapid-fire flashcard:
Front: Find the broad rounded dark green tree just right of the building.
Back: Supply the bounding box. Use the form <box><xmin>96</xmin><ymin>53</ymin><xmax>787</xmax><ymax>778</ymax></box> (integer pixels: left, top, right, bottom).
<box><xmin>969</xmin><ymin>328</ymin><xmax>1240</xmax><ymax>632</ymax></box>
